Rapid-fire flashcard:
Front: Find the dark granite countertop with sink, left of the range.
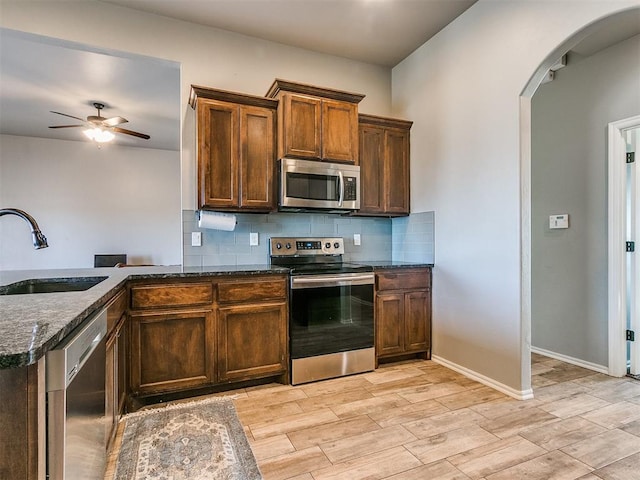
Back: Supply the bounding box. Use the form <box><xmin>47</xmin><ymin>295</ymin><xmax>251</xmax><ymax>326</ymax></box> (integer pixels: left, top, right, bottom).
<box><xmin>0</xmin><ymin>265</ymin><xmax>289</xmax><ymax>369</ymax></box>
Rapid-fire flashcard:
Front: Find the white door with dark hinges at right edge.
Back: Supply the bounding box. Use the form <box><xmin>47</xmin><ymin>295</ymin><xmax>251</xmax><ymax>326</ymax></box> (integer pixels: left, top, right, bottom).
<box><xmin>625</xmin><ymin>127</ymin><xmax>640</xmax><ymax>375</ymax></box>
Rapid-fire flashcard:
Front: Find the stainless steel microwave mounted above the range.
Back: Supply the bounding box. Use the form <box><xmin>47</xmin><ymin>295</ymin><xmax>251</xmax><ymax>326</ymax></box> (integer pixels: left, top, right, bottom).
<box><xmin>278</xmin><ymin>158</ymin><xmax>360</xmax><ymax>212</ymax></box>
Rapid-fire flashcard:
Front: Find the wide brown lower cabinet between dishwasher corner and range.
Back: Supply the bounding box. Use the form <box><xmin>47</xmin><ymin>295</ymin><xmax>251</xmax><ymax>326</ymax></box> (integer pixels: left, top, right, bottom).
<box><xmin>129</xmin><ymin>275</ymin><xmax>288</xmax><ymax>397</ymax></box>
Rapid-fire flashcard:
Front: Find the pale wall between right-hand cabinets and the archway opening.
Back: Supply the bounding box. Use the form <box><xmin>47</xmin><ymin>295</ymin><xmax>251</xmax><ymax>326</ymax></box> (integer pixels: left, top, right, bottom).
<box><xmin>392</xmin><ymin>0</ymin><xmax>640</xmax><ymax>394</ymax></box>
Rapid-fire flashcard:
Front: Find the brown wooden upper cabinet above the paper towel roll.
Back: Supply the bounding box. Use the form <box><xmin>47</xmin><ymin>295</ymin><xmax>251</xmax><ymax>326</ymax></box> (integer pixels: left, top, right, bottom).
<box><xmin>189</xmin><ymin>85</ymin><xmax>278</xmax><ymax>212</ymax></box>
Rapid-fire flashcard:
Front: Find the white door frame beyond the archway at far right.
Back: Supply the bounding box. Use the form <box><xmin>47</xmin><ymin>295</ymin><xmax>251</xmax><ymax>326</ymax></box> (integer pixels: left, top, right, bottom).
<box><xmin>607</xmin><ymin>115</ymin><xmax>640</xmax><ymax>377</ymax></box>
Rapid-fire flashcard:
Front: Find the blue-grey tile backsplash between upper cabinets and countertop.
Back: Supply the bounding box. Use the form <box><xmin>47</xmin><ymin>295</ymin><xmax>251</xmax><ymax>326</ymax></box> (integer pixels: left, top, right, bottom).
<box><xmin>182</xmin><ymin>210</ymin><xmax>434</xmax><ymax>267</ymax></box>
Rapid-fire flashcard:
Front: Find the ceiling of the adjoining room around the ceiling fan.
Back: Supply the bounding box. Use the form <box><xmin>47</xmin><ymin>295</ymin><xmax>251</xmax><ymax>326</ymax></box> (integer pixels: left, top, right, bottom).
<box><xmin>0</xmin><ymin>29</ymin><xmax>180</xmax><ymax>151</ymax></box>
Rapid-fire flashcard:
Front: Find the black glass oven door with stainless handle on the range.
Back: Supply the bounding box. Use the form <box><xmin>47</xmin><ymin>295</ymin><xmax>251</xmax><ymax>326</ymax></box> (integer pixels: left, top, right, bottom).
<box><xmin>290</xmin><ymin>273</ymin><xmax>374</xmax><ymax>359</ymax></box>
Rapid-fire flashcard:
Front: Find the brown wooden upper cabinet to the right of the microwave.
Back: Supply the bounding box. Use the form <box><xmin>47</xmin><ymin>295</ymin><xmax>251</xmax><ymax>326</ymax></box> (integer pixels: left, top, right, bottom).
<box><xmin>356</xmin><ymin>114</ymin><xmax>413</xmax><ymax>216</ymax></box>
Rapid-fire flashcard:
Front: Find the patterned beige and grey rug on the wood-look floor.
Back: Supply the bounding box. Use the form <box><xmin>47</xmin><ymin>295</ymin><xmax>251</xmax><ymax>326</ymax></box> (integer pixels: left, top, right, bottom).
<box><xmin>114</xmin><ymin>397</ymin><xmax>262</xmax><ymax>480</ymax></box>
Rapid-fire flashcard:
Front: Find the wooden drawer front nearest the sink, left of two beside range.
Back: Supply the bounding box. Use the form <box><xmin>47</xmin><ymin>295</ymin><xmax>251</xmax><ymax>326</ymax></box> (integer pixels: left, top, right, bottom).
<box><xmin>131</xmin><ymin>283</ymin><xmax>213</xmax><ymax>309</ymax></box>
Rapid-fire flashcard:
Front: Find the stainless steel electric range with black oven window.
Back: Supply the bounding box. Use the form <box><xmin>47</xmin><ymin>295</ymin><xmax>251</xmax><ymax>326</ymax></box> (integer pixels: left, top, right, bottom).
<box><xmin>270</xmin><ymin>237</ymin><xmax>375</xmax><ymax>385</ymax></box>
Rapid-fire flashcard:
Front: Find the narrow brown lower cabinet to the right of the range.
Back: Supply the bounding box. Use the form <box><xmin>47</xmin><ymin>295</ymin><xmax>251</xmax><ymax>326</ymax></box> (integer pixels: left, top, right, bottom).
<box><xmin>375</xmin><ymin>268</ymin><xmax>431</xmax><ymax>360</ymax></box>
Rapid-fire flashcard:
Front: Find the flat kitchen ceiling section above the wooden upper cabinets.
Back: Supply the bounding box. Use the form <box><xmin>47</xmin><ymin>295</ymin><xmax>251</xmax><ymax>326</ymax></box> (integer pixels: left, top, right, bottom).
<box><xmin>102</xmin><ymin>0</ymin><xmax>477</xmax><ymax>67</ymax></box>
